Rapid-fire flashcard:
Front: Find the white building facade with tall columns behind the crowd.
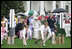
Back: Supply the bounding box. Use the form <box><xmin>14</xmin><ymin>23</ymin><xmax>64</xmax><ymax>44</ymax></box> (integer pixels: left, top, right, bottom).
<box><xmin>23</xmin><ymin>1</ymin><xmax>71</xmax><ymax>15</ymax></box>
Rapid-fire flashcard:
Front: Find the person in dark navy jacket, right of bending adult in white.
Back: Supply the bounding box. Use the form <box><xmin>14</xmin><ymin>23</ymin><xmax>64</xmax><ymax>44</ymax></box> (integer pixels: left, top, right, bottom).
<box><xmin>47</xmin><ymin>13</ymin><xmax>56</xmax><ymax>44</ymax></box>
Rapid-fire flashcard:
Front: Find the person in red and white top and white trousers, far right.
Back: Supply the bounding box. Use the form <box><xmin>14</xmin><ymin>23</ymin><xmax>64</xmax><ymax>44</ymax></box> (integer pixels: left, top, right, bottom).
<box><xmin>64</xmin><ymin>13</ymin><xmax>71</xmax><ymax>37</ymax></box>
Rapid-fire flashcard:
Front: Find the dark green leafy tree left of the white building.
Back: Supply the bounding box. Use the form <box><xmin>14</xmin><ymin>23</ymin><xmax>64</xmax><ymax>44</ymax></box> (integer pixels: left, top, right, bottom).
<box><xmin>1</xmin><ymin>1</ymin><xmax>24</xmax><ymax>18</ymax></box>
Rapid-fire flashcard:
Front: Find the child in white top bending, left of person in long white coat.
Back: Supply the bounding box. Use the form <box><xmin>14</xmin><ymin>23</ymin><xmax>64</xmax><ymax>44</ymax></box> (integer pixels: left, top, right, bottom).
<box><xmin>23</xmin><ymin>26</ymin><xmax>32</xmax><ymax>45</ymax></box>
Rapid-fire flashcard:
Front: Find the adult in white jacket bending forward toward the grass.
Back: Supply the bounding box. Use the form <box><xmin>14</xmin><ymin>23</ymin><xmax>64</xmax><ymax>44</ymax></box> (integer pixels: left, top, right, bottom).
<box><xmin>40</xmin><ymin>22</ymin><xmax>51</xmax><ymax>46</ymax></box>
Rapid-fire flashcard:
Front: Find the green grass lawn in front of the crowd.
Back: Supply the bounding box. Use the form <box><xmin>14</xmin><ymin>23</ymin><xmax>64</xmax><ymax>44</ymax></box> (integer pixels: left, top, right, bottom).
<box><xmin>1</xmin><ymin>37</ymin><xmax>71</xmax><ymax>48</ymax></box>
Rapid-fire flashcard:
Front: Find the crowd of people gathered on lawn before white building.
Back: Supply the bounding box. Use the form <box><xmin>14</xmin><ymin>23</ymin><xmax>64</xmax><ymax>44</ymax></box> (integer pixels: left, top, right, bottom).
<box><xmin>1</xmin><ymin>10</ymin><xmax>71</xmax><ymax>46</ymax></box>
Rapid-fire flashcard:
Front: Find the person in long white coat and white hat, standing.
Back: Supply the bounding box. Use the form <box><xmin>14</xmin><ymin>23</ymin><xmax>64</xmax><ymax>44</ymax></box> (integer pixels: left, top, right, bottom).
<box><xmin>33</xmin><ymin>16</ymin><xmax>41</xmax><ymax>44</ymax></box>
